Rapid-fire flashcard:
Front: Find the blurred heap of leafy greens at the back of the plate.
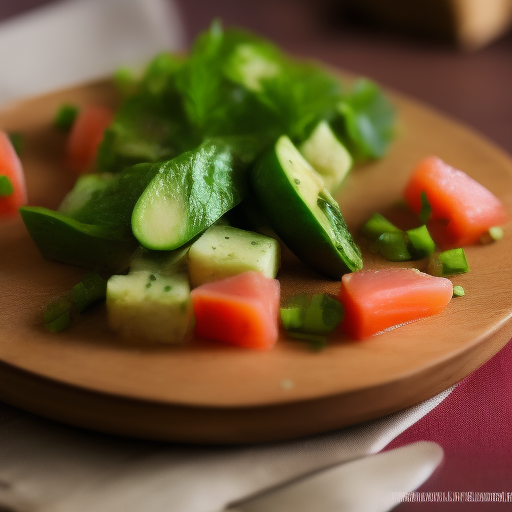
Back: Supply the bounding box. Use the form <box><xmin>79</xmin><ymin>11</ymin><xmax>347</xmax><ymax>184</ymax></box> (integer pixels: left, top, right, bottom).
<box><xmin>97</xmin><ymin>22</ymin><xmax>393</xmax><ymax>172</ymax></box>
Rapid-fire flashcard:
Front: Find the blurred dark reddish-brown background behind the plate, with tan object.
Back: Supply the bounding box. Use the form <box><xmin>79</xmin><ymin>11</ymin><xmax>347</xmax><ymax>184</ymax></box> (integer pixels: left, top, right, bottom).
<box><xmin>0</xmin><ymin>0</ymin><xmax>512</xmax><ymax>154</ymax></box>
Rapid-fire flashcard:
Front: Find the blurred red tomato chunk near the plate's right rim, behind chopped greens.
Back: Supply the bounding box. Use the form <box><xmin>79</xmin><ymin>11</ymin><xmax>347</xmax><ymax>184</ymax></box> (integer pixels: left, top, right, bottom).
<box><xmin>404</xmin><ymin>156</ymin><xmax>508</xmax><ymax>247</ymax></box>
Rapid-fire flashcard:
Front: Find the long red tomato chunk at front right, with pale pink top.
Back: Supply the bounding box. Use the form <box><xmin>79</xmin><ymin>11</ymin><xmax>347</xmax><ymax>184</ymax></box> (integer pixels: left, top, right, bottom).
<box><xmin>339</xmin><ymin>268</ymin><xmax>453</xmax><ymax>340</ymax></box>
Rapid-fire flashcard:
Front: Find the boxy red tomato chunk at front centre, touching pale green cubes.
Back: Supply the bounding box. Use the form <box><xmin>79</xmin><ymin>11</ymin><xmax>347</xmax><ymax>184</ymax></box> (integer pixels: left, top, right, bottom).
<box><xmin>191</xmin><ymin>272</ymin><xmax>280</xmax><ymax>350</ymax></box>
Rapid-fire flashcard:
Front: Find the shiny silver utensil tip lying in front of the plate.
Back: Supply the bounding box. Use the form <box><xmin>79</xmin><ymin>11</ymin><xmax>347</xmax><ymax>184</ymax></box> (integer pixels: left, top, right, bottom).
<box><xmin>218</xmin><ymin>441</ymin><xmax>443</xmax><ymax>512</ymax></box>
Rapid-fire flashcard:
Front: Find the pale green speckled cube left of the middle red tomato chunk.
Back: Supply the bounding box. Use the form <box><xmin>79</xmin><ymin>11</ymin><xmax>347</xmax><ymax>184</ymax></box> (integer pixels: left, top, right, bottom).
<box><xmin>107</xmin><ymin>250</ymin><xmax>193</xmax><ymax>344</ymax></box>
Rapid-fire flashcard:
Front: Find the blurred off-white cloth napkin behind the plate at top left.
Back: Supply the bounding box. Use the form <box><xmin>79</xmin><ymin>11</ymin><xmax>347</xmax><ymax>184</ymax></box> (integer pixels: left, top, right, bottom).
<box><xmin>0</xmin><ymin>0</ymin><xmax>185</xmax><ymax>104</ymax></box>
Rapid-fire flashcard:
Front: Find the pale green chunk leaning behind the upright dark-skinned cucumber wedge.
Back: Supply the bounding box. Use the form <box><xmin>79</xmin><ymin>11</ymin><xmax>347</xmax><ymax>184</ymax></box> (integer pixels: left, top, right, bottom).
<box><xmin>299</xmin><ymin>121</ymin><xmax>353</xmax><ymax>194</ymax></box>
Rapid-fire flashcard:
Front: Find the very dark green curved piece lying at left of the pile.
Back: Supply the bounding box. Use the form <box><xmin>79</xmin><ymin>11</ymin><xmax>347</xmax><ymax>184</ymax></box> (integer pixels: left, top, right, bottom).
<box><xmin>20</xmin><ymin>206</ymin><xmax>137</xmax><ymax>270</ymax></box>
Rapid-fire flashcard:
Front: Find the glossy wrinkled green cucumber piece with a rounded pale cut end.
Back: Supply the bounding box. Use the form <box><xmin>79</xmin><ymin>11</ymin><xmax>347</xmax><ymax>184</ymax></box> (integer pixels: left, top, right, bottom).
<box><xmin>132</xmin><ymin>138</ymin><xmax>255</xmax><ymax>250</ymax></box>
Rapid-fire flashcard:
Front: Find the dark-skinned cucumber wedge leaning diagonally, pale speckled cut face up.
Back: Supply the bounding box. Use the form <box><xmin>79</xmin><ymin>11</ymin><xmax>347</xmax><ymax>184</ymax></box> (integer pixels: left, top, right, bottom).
<box><xmin>252</xmin><ymin>135</ymin><xmax>363</xmax><ymax>279</ymax></box>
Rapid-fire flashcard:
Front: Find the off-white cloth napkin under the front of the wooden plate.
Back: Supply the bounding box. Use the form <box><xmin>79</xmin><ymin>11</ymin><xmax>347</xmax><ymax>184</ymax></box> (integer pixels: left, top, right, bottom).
<box><xmin>0</xmin><ymin>389</ymin><xmax>451</xmax><ymax>512</ymax></box>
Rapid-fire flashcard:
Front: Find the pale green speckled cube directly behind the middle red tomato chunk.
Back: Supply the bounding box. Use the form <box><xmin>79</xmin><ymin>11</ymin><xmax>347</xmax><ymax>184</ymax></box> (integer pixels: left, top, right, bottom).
<box><xmin>188</xmin><ymin>226</ymin><xmax>280</xmax><ymax>288</ymax></box>
